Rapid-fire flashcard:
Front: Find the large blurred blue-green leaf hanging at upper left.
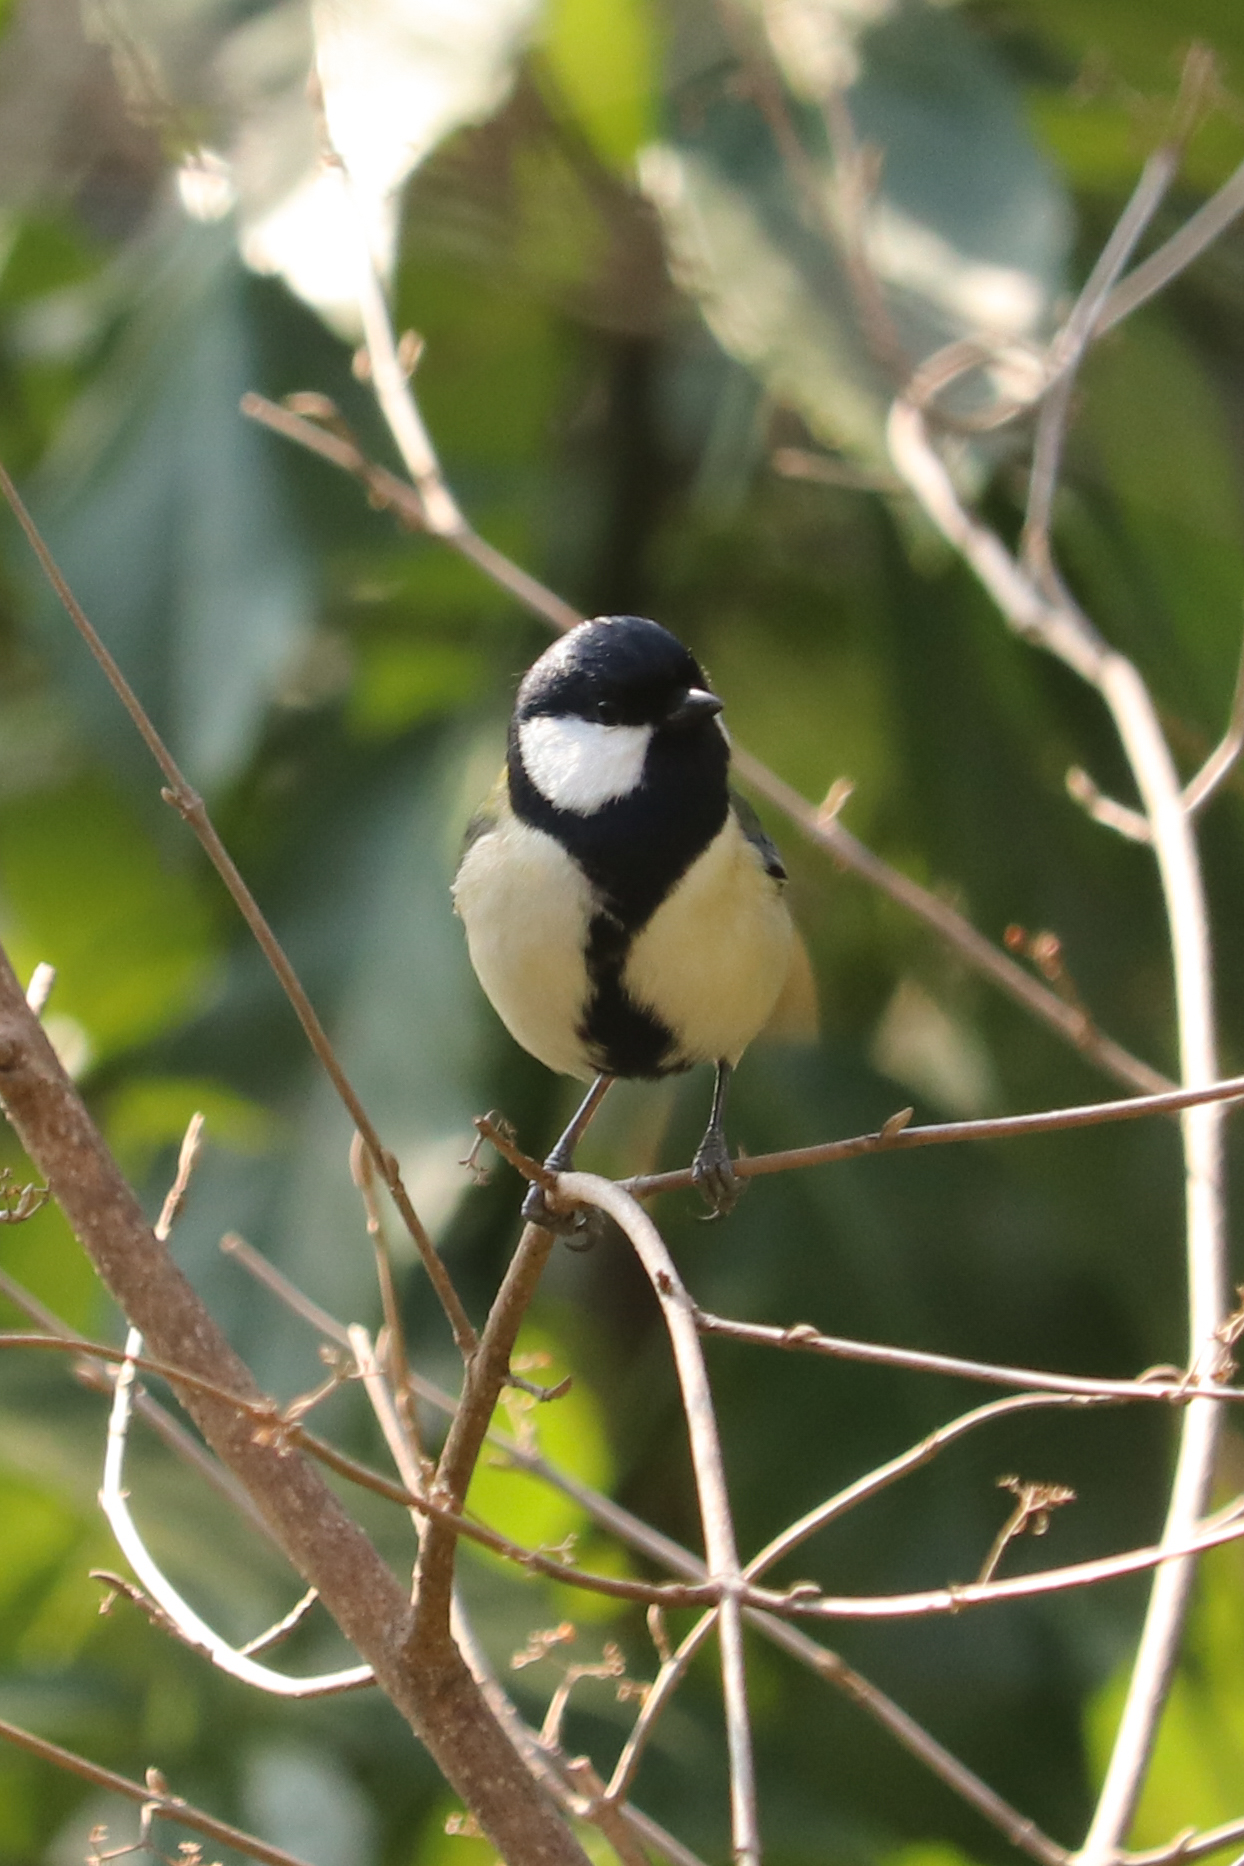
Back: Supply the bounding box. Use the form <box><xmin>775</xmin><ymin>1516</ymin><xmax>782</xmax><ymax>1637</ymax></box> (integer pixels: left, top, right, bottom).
<box><xmin>35</xmin><ymin>226</ymin><xmax>311</xmax><ymax>786</ymax></box>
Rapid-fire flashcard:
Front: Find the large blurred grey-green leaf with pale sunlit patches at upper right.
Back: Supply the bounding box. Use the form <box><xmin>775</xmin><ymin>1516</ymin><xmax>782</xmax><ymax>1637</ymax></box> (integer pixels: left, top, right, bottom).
<box><xmin>642</xmin><ymin>6</ymin><xmax>1069</xmax><ymax>465</ymax></box>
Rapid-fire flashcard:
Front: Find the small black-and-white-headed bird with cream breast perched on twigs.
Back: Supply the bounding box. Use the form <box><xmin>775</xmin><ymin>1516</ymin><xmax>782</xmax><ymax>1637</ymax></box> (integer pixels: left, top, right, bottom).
<box><xmin>453</xmin><ymin>616</ymin><xmax>793</xmax><ymax>1222</ymax></box>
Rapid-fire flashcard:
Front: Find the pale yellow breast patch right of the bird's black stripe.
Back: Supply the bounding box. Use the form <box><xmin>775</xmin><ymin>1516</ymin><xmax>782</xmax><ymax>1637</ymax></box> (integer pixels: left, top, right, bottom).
<box><xmin>623</xmin><ymin>814</ymin><xmax>793</xmax><ymax>1064</ymax></box>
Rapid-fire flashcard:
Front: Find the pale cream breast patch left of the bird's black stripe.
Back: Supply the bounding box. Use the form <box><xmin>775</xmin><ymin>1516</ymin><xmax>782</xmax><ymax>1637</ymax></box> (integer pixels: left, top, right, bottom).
<box><xmin>453</xmin><ymin>817</ymin><xmax>595</xmax><ymax>1080</ymax></box>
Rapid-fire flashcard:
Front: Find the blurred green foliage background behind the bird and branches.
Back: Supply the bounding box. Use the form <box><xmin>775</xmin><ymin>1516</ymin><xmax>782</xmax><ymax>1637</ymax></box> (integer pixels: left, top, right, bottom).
<box><xmin>0</xmin><ymin>0</ymin><xmax>1244</xmax><ymax>1866</ymax></box>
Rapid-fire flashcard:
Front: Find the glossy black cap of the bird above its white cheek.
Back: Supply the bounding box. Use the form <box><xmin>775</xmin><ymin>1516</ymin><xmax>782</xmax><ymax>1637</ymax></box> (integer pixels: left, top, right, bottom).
<box><xmin>515</xmin><ymin>616</ymin><xmax>722</xmax><ymax>728</ymax></box>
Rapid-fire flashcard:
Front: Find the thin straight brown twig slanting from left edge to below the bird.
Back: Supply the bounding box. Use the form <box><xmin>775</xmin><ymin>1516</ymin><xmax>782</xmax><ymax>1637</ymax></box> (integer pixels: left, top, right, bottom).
<box><xmin>0</xmin><ymin>451</ymin><xmax>476</xmax><ymax>1355</ymax></box>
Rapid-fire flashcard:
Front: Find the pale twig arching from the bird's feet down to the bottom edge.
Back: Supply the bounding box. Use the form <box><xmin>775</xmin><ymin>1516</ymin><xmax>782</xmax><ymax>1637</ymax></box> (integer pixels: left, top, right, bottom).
<box><xmin>558</xmin><ymin>1172</ymin><xmax>761</xmax><ymax>1866</ymax></box>
